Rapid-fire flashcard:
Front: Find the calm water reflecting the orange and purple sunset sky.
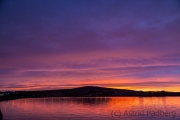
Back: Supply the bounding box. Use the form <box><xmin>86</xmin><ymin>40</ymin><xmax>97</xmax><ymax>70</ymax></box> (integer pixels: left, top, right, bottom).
<box><xmin>0</xmin><ymin>97</ymin><xmax>180</xmax><ymax>120</ymax></box>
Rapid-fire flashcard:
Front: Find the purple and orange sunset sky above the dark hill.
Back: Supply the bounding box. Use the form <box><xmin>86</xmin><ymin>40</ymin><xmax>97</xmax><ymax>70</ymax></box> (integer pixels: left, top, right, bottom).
<box><xmin>0</xmin><ymin>0</ymin><xmax>180</xmax><ymax>91</ymax></box>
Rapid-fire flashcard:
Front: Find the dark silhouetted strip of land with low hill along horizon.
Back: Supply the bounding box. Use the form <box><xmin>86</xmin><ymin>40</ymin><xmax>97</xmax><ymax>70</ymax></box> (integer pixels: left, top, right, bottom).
<box><xmin>0</xmin><ymin>86</ymin><xmax>180</xmax><ymax>101</ymax></box>
